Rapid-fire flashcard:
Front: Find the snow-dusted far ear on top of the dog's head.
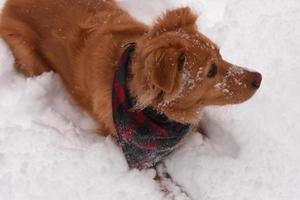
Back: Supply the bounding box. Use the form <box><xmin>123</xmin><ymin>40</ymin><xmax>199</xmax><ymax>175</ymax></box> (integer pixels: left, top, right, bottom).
<box><xmin>149</xmin><ymin>7</ymin><xmax>197</xmax><ymax>36</ymax></box>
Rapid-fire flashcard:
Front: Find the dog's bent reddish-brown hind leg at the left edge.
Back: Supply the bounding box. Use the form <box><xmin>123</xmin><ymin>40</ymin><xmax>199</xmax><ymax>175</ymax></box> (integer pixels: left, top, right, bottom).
<box><xmin>0</xmin><ymin>20</ymin><xmax>50</xmax><ymax>76</ymax></box>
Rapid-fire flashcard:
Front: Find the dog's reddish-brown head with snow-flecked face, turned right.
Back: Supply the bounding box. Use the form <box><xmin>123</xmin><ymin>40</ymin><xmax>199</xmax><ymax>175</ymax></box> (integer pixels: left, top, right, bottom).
<box><xmin>129</xmin><ymin>8</ymin><xmax>262</xmax><ymax>123</ymax></box>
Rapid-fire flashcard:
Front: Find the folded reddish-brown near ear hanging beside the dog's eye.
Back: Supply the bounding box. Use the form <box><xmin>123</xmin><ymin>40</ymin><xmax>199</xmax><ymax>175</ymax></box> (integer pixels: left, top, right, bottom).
<box><xmin>150</xmin><ymin>48</ymin><xmax>179</xmax><ymax>93</ymax></box>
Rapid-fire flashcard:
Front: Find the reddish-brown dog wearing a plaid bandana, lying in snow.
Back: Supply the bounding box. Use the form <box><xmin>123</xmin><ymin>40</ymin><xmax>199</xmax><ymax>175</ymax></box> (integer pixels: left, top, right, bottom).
<box><xmin>0</xmin><ymin>0</ymin><xmax>262</xmax><ymax>169</ymax></box>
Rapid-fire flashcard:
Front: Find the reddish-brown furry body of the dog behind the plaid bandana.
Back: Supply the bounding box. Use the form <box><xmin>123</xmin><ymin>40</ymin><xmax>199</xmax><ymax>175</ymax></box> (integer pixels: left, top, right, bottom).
<box><xmin>0</xmin><ymin>0</ymin><xmax>147</xmax><ymax>133</ymax></box>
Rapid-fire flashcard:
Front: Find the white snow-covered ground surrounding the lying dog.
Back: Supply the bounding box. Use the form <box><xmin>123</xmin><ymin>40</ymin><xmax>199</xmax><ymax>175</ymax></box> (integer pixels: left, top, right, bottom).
<box><xmin>0</xmin><ymin>0</ymin><xmax>300</xmax><ymax>200</ymax></box>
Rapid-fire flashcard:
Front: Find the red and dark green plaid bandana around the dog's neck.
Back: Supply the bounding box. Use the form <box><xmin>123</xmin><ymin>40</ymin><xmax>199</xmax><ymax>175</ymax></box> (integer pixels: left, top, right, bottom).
<box><xmin>112</xmin><ymin>44</ymin><xmax>191</xmax><ymax>169</ymax></box>
